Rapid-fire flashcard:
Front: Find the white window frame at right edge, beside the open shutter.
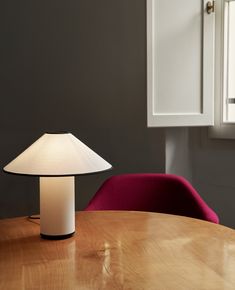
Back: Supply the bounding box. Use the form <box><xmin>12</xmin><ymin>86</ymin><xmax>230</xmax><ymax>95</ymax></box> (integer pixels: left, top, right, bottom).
<box><xmin>209</xmin><ymin>0</ymin><xmax>235</xmax><ymax>139</ymax></box>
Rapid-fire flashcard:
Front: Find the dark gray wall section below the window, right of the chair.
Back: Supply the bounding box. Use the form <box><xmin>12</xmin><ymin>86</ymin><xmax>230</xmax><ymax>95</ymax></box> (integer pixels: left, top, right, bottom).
<box><xmin>190</xmin><ymin>128</ymin><xmax>235</xmax><ymax>228</ymax></box>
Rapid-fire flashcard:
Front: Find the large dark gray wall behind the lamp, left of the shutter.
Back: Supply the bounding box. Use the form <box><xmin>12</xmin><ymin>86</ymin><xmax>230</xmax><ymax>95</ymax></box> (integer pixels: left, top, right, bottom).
<box><xmin>0</xmin><ymin>0</ymin><xmax>164</xmax><ymax>217</ymax></box>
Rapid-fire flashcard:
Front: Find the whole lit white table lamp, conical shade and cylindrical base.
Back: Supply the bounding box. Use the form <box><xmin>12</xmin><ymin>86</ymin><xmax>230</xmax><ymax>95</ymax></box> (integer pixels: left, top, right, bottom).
<box><xmin>3</xmin><ymin>132</ymin><xmax>112</xmax><ymax>239</ymax></box>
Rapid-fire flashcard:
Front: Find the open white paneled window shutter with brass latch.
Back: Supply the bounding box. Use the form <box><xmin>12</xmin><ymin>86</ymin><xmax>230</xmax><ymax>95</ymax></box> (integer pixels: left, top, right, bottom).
<box><xmin>147</xmin><ymin>0</ymin><xmax>215</xmax><ymax>127</ymax></box>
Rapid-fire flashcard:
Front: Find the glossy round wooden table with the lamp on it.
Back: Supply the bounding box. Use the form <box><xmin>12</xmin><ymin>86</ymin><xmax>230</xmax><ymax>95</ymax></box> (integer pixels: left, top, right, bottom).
<box><xmin>0</xmin><ymin>211</ymin><xmax>235</xmax><ymax>290</ymax></box>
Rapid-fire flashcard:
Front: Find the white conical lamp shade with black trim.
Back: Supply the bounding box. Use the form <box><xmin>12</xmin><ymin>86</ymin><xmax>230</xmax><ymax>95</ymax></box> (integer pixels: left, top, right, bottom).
<box><xmin>4</xmin><ymin>133</ymin><xmax>112</xmax><ymax>176</ymax></box>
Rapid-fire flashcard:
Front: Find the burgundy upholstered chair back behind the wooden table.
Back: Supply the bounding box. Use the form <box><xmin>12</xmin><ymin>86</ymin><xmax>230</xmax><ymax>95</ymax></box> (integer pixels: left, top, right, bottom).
<box><xmin>85</xmin><ymin>174</ymin><xmax>219</xmax><ymax>223</ymax></box>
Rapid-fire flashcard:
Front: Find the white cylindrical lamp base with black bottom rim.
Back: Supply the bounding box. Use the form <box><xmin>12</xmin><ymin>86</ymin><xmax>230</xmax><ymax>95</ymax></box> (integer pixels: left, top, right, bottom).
<box><xmin>40</xmin><ymin>176</ymin><xmax>75</xmax><ymax>239</ymax></box>
